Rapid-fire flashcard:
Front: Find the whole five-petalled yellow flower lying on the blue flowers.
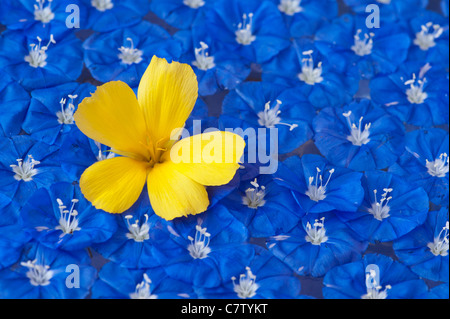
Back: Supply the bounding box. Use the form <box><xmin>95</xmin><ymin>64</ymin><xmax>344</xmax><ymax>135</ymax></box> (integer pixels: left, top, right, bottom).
<box><xmin>74</xmin><ymin>57</ymin><xmax>245</xmax><ymax>220</ymax></box>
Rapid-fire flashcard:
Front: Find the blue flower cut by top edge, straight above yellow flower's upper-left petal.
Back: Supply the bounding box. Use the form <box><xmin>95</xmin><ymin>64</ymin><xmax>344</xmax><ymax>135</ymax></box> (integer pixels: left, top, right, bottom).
<box><xmin>79</xmin><ymin>0</ymin><xmax>150</xmax><ymax>32</ymax></box>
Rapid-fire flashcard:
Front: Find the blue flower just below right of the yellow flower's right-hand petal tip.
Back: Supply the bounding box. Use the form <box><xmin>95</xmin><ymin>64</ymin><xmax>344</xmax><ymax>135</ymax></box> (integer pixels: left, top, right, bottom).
<box><xmin>220</xmin><ymin>175</ymin><xmax>304</xmax><ymax>237</ymax></box>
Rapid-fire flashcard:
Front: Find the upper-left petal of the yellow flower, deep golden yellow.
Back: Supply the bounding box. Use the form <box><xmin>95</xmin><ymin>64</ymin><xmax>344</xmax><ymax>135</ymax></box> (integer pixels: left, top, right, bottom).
<box><xmin>74</xmin><ymin>81</ymin><xmax>148</xmax><ymax>159</ymax></box>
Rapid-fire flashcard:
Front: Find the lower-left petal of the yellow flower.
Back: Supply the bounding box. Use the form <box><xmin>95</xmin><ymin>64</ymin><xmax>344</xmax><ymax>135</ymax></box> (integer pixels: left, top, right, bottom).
<box><xmin>80</xmin><ymin>157</ymin><xmax>148</xmax><ymax>214</ymax></box>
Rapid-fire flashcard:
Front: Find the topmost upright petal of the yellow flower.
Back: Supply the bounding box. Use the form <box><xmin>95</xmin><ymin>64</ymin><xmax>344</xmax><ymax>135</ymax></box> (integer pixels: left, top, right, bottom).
<box><xmin>138</xmin><ymin>56</ymin><xmax>198</xmax><ymax>147</ymax></box>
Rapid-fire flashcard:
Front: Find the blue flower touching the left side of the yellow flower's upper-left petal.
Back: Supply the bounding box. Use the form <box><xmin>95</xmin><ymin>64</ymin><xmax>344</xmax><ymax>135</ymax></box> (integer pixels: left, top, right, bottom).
<box><xmin>22</xmin><ymin>82</ymin><xmax>95</xmax><ymax>145</ymax></box>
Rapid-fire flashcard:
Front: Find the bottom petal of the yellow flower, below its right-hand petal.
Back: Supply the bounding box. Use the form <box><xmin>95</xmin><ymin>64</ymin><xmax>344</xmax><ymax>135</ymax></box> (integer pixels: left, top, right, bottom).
<box><xmin>147</xmin><ymin>162</ymin><xmax>209</xmax><ymax>220</ymax></box>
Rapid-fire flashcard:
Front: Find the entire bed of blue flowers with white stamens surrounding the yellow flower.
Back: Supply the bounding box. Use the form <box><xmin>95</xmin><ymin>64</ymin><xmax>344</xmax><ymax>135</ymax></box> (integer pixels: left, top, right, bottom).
<box><xmin>0</xmin><ymin>0</ymin><xmax>450</xmax><ymax>299</ymax></box>
